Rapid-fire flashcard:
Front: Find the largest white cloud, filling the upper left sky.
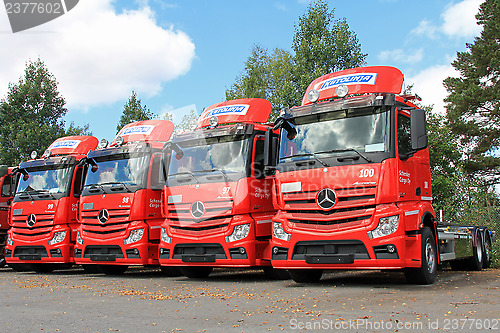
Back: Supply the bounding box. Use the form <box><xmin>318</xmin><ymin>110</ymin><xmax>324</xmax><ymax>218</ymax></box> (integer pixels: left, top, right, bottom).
<box><xmin>0</xmin><ymin>0</ymin><xmax>195</xmax><ymax>109</ymax></box>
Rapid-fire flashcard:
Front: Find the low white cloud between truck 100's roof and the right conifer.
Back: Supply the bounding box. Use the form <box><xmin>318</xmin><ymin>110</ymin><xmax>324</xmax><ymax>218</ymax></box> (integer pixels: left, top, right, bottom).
<box><xmin>405</xmin><ymin>65</ymin><xmax>459</xmax><ymax>114</ymax></box>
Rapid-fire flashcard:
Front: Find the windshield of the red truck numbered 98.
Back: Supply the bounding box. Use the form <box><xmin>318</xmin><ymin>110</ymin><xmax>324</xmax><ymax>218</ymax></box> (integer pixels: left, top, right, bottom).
<box><xmin>85</xmin><ymin>154</ymin><xmax>150</xmax><ymax>193</ymax></box>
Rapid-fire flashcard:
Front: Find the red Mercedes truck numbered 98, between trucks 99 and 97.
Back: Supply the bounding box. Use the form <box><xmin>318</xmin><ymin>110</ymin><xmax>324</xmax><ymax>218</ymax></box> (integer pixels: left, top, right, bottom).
<box><xmin>74</xmin><ymin>120</ymin><xmax>174</xmax><ymax>274</ymax></box>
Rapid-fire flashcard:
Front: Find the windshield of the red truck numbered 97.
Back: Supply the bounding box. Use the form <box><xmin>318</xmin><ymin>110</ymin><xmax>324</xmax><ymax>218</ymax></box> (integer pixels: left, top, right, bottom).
<box><xmin>168</xmin><ymin>135</ymin><xmax>249</xmax><ymax>184</ymax></box>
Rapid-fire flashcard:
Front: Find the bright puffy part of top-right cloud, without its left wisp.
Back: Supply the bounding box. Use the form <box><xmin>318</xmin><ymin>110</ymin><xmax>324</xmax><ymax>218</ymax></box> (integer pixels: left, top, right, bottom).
<box><xmin>441</xmin><ymin>0</ymin><xmax>483</xmax><ymax>37</ymax></box>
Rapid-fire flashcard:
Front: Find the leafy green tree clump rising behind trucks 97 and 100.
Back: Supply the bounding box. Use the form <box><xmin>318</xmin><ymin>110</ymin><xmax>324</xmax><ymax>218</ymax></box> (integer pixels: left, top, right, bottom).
<box><xmin>226</xmin><ymin>0</ymin><xmax>366</xmax><ymax>118</ymax></box>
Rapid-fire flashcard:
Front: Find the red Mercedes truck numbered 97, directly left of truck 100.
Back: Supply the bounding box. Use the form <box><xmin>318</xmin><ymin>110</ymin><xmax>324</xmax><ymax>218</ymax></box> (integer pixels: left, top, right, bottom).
<box><xmin>159</xmin><ymin>98</ymin><xmax>288</xmax><ymax>278</ymax></box>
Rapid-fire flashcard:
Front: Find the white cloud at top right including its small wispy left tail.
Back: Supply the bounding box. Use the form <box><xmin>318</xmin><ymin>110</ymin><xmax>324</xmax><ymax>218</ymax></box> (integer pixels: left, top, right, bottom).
<box><xmin>410</xmin><ymin>0</ymin><xmax>484</xmax><ymax>39</ymax></box>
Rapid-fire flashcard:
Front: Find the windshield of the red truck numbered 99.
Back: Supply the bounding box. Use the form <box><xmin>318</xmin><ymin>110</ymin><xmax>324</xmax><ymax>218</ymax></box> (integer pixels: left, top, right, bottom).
<box><xmin>17</xmin><ymin>164</ymin><xmax>74</xmax><ymax>200</ymax></box>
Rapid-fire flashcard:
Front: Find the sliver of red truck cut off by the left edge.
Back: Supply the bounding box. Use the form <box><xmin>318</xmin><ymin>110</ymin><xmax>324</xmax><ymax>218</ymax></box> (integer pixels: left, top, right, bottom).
<box><xmin>0</xmin><ymin>165</ymin><xmax>16</xmax><ymax>267</ymax></box>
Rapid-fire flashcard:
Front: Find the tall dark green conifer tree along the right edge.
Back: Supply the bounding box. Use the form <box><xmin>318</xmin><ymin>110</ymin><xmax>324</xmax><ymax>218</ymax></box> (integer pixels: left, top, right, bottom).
<box><xmin>444</xmin><ymin>0</ymin><xmax>500</xmax><ymax>184</ymax></box>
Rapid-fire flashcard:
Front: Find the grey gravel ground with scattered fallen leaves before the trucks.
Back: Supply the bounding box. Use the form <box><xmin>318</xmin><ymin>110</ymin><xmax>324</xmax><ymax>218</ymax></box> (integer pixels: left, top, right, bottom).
<box><xmin>0</xmin><ymin>268</ymin><xmax>500</xmax><ymax>332</ymax></box>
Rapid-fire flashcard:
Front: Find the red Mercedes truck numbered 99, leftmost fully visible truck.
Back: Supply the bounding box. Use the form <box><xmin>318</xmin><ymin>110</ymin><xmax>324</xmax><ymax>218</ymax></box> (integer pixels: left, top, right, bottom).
<box><xmin>5</xmin><ymin>136</ymin><xmax>98</xmax><ymax>272</ymax></box>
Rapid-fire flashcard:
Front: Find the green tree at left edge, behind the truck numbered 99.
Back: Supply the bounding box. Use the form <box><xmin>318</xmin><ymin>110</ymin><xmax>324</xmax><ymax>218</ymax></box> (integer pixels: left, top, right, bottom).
<box><xmin>0</xmin><ymin>59</ymin><xmax>89</xmax><ymax>165</ymax></box>
